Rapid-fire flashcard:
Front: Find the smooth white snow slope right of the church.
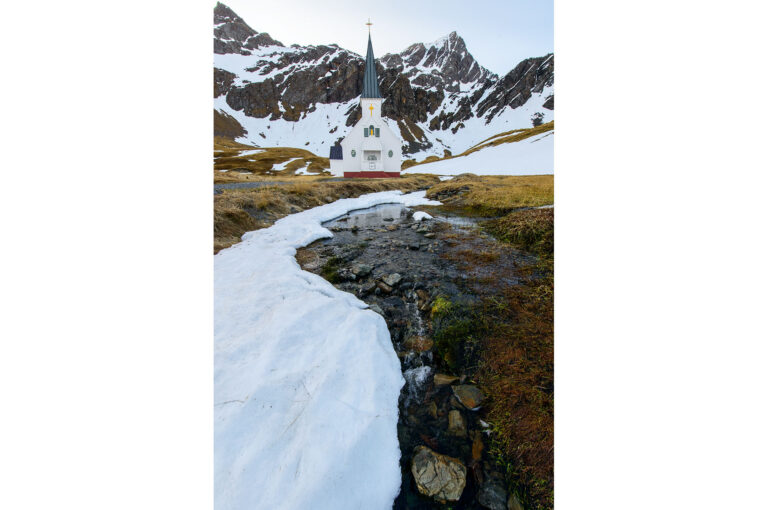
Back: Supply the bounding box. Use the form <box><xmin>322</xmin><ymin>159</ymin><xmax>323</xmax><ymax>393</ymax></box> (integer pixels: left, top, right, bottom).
<box><xmin>403</xmin><ymin>131</ymin><xmax>555</xmax><ymax>175</ymax></box>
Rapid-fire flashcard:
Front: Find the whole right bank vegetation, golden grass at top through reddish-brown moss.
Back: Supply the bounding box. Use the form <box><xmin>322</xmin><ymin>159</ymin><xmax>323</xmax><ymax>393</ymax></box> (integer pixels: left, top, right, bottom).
<box><xmin>427</xmin><ymin>181</ymin><xmax>554</xmax><ymax>509</ymax></box>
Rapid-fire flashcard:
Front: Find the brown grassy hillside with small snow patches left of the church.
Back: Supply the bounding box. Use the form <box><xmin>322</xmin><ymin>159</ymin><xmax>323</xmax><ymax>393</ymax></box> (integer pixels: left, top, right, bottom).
<box><xmin>213</xmin><ymin>136</ymin><xmax>330</xmax><ymax>183</ymax></box>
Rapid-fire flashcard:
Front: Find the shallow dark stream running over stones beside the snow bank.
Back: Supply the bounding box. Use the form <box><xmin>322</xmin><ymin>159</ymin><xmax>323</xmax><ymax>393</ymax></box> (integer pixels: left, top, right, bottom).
<box><xmin>296</xmin><ymin>204</ymin><xmax>534</xmax><ymax>509</ymax></box>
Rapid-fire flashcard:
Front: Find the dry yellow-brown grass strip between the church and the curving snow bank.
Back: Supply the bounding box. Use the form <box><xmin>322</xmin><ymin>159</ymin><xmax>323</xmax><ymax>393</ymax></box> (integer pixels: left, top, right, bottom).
<box><xmin>213</xmin><ymin>174</ymin><xmax>439</xmax><ymax>253</ymax></box>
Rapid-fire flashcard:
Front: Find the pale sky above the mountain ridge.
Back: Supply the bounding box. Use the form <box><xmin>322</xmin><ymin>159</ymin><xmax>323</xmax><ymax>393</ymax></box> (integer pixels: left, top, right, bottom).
<box><xmin>213</xmin><ymin>0</ymin><xmax>554</xmax><ymax>75</ymax></box>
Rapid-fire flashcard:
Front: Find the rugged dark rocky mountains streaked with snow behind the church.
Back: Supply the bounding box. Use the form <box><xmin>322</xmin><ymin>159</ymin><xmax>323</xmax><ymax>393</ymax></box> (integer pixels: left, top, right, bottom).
<box><xmin>213</xmin><ymin>3</ymin><xmax>554</xmax><ymax>159</ymax></box>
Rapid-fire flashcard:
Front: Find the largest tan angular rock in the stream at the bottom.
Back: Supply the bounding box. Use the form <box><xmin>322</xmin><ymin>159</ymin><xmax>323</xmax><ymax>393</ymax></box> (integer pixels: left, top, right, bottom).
<box><xmin>411</xmin><ymin>446</ymin><xmax>467</xmax><ymax>502</ymax></box>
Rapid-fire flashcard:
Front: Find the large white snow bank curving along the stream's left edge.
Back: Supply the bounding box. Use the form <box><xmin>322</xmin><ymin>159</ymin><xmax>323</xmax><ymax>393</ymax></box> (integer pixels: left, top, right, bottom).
<box><xmin>214</xmin><ymin>191</ymin><xmax>438</xmax><ymax>510</ymax></box>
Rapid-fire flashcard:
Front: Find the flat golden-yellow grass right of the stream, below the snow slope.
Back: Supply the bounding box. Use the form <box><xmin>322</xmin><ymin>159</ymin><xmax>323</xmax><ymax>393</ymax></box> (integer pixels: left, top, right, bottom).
<box><xmin>427</xmin><ymin>174</ymin><xmax>555</xmax><ymax>216</ymax></box>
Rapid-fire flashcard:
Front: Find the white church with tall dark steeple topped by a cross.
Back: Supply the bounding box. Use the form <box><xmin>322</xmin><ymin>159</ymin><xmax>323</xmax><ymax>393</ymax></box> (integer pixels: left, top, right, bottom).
<box><xmin>330</xmin><ymin>28</ymin><xmax>402</xmax><ymax>177</ymax></box>
